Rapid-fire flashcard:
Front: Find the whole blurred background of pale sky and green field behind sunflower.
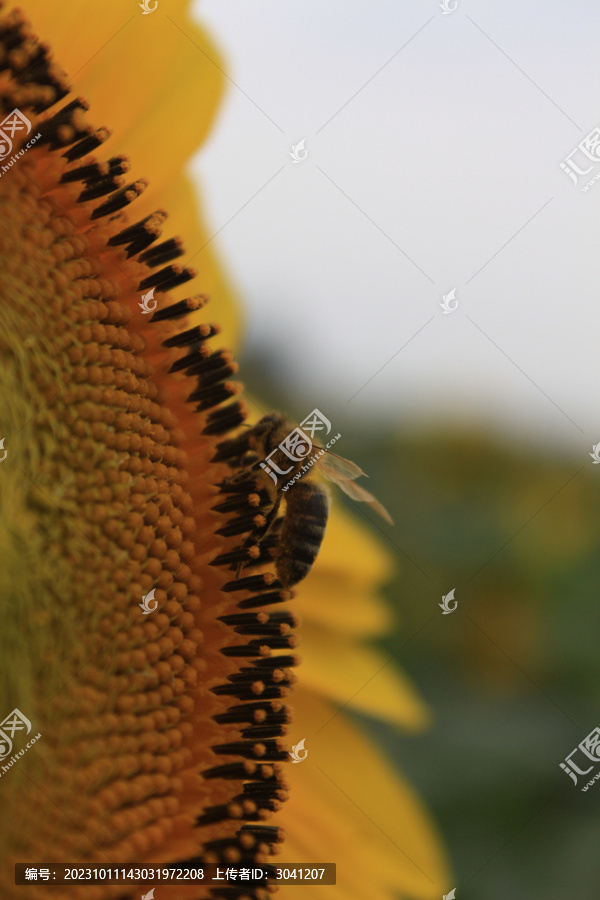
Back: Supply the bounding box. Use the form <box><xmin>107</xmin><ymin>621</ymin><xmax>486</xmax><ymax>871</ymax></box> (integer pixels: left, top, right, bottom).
<box><xmin>192</xmin><ymin>0</ymin><xmax>600</xmax><ymax>900</ymax></box>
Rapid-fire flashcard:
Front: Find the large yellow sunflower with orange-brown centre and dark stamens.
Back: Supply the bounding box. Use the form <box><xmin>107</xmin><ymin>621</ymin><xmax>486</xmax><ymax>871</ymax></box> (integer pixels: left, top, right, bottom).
<box><xmin>0</xmin><ymin>0</ymin><xmax>447</xmax><ymax>900</ymax></box>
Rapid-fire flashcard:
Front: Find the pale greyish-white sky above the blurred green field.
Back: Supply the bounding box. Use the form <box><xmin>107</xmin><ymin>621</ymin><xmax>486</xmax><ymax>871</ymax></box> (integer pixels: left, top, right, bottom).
<box><xmin>193</xmin><ymin>0</ymin><xmax>600</xmax><ymax>450</ymax></box>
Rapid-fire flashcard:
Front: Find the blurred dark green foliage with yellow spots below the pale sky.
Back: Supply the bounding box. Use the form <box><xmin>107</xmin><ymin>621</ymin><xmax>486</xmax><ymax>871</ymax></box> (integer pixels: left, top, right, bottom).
<box><xmin>345</xmin><ymin>428</ymin><xmax>600</xmax><ymax>900</ymax></box>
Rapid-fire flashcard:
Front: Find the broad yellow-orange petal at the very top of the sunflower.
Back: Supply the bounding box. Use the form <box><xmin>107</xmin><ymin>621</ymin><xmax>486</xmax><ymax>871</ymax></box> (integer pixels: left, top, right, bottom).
<box><xmin>12</xmin><ymin>0</ymin><xmax>225</xmax><ymax>188</ymax></box>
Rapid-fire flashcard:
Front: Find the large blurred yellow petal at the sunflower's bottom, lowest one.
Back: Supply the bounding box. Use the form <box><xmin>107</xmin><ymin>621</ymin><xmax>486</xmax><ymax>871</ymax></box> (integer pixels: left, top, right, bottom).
<box><xmin>280</xmin><ymin>688</ymin><xmax>449</xmax><ymax>900</ymax></box>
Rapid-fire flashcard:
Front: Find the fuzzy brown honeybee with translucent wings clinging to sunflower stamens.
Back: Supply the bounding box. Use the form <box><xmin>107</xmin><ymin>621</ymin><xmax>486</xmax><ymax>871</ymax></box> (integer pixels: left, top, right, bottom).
<box><xmin>215</xmin><ymin>413</ymin><xmax>393</xmax><ymax>588</ymax></box>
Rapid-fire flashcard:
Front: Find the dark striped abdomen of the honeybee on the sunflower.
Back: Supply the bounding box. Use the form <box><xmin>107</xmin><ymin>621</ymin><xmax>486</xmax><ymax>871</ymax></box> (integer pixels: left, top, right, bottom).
<box><xmin>276</xmin><ymin>482</ymin><xmax>329</xmax><ymax>587</ymax></box>
